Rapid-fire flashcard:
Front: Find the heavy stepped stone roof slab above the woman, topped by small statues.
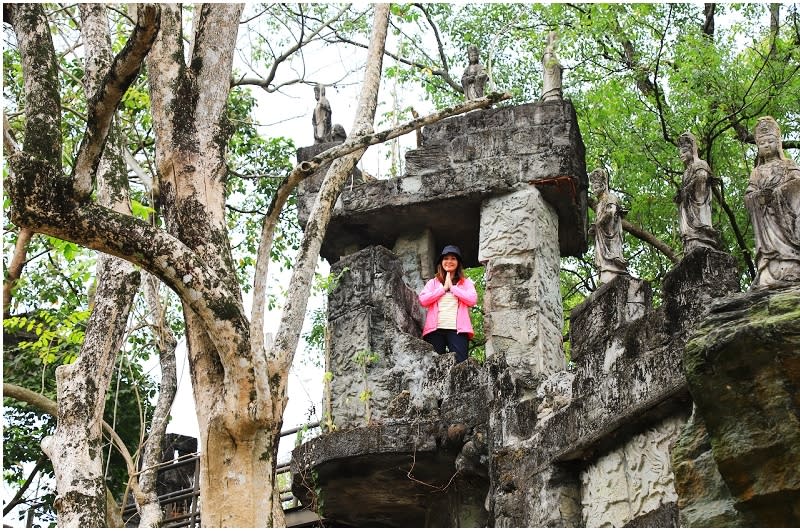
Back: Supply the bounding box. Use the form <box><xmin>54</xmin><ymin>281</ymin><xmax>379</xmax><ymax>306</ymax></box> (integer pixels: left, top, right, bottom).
<box><xmin>298</xmin><ymin>101</ymin><xmax>587</xmax><ymax>264</ymax></box>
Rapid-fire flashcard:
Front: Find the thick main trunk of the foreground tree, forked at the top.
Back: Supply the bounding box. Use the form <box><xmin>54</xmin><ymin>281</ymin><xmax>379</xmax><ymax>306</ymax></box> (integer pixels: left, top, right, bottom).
<box><xmin>148</xmin><ymin>4</ymin><xmax>283</xmax><ymax>527</ymax></box>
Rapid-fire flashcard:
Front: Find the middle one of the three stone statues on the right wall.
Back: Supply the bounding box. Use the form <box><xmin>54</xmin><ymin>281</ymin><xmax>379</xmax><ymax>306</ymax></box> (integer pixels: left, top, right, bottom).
<box><xmin>675</xmin><ymin>133</ymin><xmax>717</xmax><ymax>254</ymax></box>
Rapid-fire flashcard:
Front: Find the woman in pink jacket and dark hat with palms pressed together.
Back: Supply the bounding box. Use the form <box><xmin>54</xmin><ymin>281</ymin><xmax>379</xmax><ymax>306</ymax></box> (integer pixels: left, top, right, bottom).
<box><xmin>419</xmin><ymin>245</ymin><xmax>478</xmax><ymax>363</ymax></box>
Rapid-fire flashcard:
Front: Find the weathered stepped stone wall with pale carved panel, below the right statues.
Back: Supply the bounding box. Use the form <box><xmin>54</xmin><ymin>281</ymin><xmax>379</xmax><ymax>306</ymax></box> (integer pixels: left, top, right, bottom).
<box><xmin>482</xmin><ymin>250</ymin><xmax>738</xmax><ymax>527</ymax></box>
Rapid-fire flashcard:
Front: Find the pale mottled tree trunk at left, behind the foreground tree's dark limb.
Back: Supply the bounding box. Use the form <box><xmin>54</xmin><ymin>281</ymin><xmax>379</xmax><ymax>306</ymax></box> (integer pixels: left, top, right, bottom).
<box><xmin>37</xmin><ymin>4</ymin><xmax>144</xmax><ymax>527</ymax></box>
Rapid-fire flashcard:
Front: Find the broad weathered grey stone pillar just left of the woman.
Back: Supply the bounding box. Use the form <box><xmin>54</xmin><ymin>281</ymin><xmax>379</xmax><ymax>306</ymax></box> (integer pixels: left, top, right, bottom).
<box><xmin>326</xmin><ymin>246</ymin><xmax>437</xmax><ymax>429</ymax></box>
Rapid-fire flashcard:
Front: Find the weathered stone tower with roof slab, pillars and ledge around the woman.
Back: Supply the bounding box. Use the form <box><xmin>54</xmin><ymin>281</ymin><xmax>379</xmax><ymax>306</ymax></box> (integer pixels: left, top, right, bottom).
<box><xmin>293</xmin><ymin>97</ymin><xmax>587</xmax><ymax>526</ymax></box>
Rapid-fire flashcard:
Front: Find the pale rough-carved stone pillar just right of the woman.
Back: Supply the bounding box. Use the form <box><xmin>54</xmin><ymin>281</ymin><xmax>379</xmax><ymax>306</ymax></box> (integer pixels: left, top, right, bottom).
<box><xmin>478</xmin><ymin>187</ymin><xmax>565</xmax><ymax>390</ymax></box>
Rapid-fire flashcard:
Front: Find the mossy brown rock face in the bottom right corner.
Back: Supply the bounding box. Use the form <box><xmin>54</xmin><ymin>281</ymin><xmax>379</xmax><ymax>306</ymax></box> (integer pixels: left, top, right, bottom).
<box><xmin>675</xmin><ymin>285</ymin><xmax>800</xmax><ymax>527</ymax></box>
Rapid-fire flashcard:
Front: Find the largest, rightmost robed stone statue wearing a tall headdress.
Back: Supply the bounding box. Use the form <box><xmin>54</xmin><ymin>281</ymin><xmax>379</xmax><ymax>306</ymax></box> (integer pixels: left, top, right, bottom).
<box><xmin>744</xmin><ymin>116</ymin><xmax>800</xmax><ymax>287</ymax></box>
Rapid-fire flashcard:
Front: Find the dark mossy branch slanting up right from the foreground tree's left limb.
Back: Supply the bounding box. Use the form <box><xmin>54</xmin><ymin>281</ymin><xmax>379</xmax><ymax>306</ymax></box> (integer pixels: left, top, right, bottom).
<box><xmin>73</xmin><ymin>4</ymin><xmax>161</xmax><ymax>198</ymax></box>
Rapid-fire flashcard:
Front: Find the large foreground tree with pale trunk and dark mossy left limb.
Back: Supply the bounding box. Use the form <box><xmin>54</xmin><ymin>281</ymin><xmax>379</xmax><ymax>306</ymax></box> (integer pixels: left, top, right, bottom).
<box><xmin>4</xmin><ymin>4</ymin><xmax>506</xmax><ymax>527</ymax></box>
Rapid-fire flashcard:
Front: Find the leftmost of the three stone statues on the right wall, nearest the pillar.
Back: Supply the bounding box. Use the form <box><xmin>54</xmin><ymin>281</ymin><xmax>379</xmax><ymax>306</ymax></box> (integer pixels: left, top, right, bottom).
<box><xmin>589</xmin><ymin>169</ymin><xmax>629</xmax><ymax>284</ymax></box>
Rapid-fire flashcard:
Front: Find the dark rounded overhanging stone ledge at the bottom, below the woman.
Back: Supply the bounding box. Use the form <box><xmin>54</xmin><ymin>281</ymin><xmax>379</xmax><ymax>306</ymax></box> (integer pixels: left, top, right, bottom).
<box><xmin>291</xmin><ymin>419</ymin><xmax>488</xmax><ymax>527</ymax></box>
